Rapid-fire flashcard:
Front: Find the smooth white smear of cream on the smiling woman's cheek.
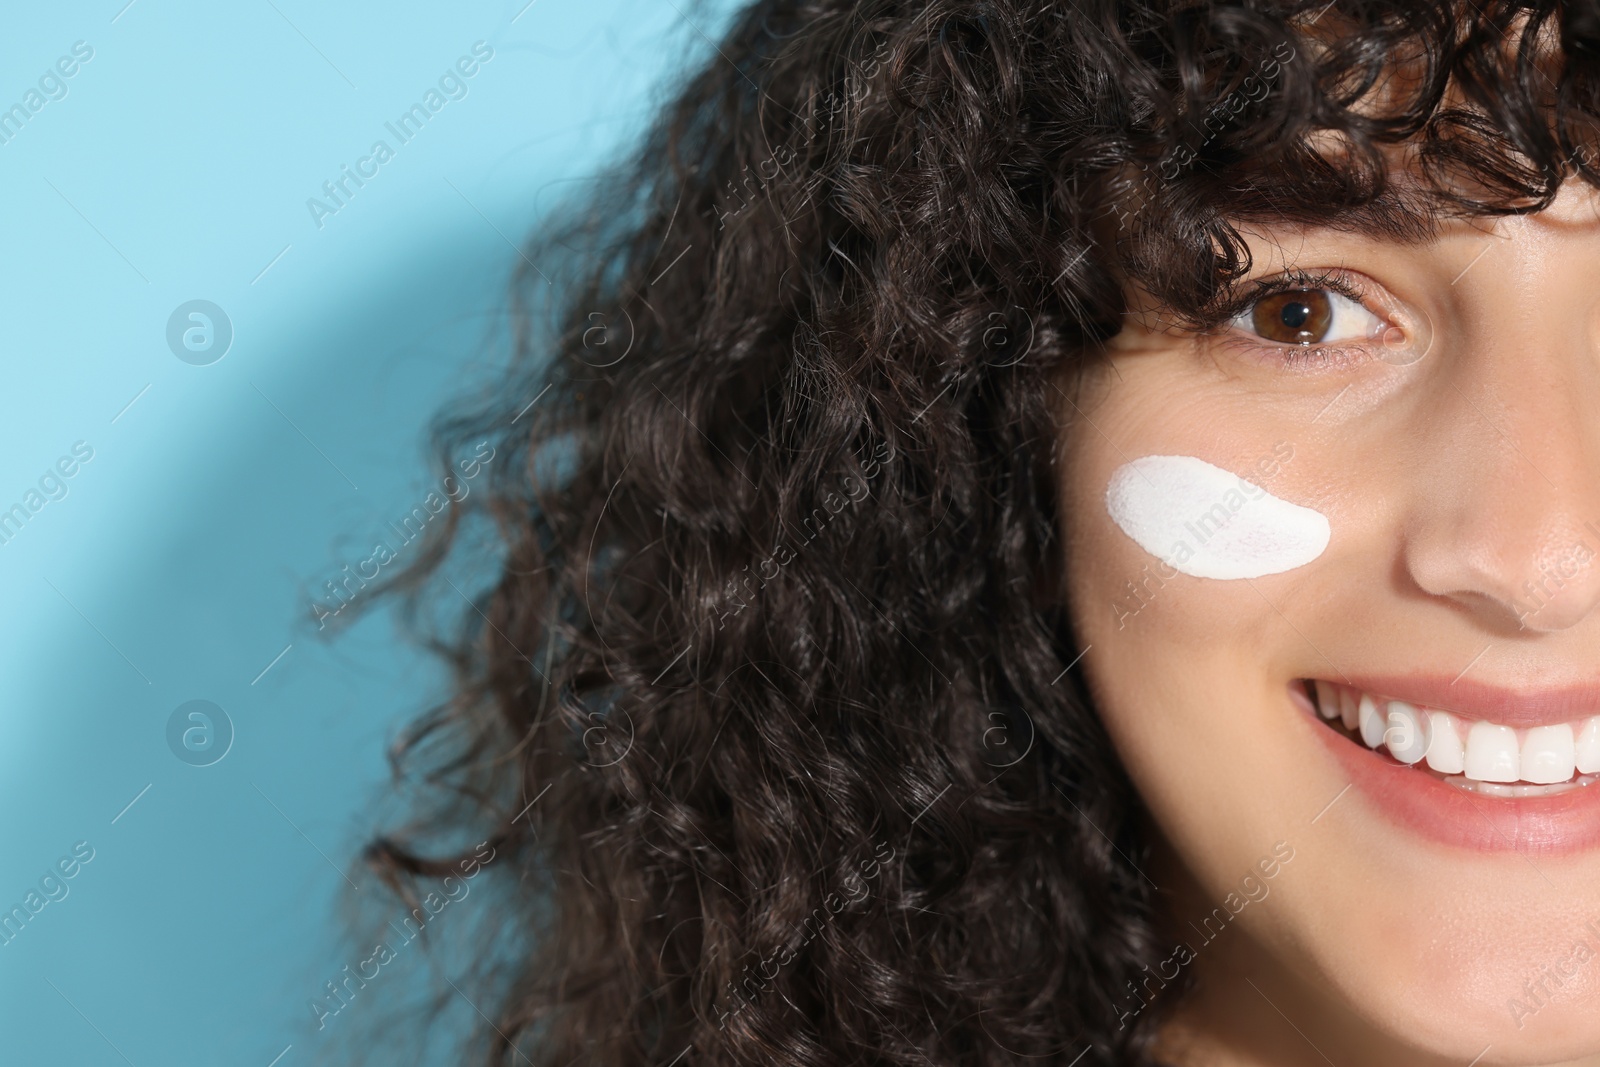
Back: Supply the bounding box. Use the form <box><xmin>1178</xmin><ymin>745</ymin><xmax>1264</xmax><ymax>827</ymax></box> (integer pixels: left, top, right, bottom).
<box><xmin>1106</xmin><ymin>456</ymin><xmax>1331</xmax><ymax>579</ymax></box>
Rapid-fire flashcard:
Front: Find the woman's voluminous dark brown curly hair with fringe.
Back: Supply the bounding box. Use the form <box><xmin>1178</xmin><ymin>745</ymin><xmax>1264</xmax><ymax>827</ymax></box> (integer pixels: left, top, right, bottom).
<box><xmin>356</xmin><ymin>0</ymin><xmax>1600</xmax><ymax>1067</ymax></box>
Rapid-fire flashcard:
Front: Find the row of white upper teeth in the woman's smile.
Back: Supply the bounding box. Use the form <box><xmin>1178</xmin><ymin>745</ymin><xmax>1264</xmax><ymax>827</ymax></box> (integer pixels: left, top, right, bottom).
<box><xmin>1315</xmin><ymin>681</ymin><xmax>1600</xmax><ymax>785</ymax></box>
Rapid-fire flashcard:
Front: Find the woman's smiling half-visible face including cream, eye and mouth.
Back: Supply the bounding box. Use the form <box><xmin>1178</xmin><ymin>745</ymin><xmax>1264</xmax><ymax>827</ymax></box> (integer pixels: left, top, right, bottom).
<box><xmin>1059</xmin><ymin>182</ymin><xmax>1600</xmax><ymax>1064</ymax></box>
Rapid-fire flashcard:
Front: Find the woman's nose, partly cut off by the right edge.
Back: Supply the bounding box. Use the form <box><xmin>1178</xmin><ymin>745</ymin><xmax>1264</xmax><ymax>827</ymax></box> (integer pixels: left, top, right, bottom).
<box><xmin>1403</xmin><ymin>286</ymin><xmax>1600</xmax><ymax>632</ymax></box>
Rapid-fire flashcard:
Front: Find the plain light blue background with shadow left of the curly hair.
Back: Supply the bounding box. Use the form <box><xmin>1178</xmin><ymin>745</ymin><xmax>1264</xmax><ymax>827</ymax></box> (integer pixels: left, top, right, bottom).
<box><xmin>0</xmin><ymin>0</ymin><xmax>731</xmax><ymax>1067</ymax></box>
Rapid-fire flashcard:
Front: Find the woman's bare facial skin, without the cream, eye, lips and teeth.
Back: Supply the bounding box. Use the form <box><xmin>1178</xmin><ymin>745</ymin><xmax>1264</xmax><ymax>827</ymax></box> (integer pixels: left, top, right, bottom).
<box><xmin>1061</xmin><ymin>182</ymin><xmax>1600</xmax><ymax>1067</ymax></box>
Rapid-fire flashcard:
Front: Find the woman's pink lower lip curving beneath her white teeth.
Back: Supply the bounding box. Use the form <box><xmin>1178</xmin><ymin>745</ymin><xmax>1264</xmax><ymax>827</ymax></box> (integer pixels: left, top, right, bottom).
<box><xmin>1290</xmin><ymin>680</ymin><xmax>1600</xmax><ymax>856</ymax></box>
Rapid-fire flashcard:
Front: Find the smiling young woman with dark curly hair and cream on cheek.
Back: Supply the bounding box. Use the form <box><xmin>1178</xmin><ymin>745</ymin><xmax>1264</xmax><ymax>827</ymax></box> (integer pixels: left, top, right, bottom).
<box><xmin>371</xmin><ymin>0</ymin><xmax>1600</xmax><ymax>1067</ymax></box>
